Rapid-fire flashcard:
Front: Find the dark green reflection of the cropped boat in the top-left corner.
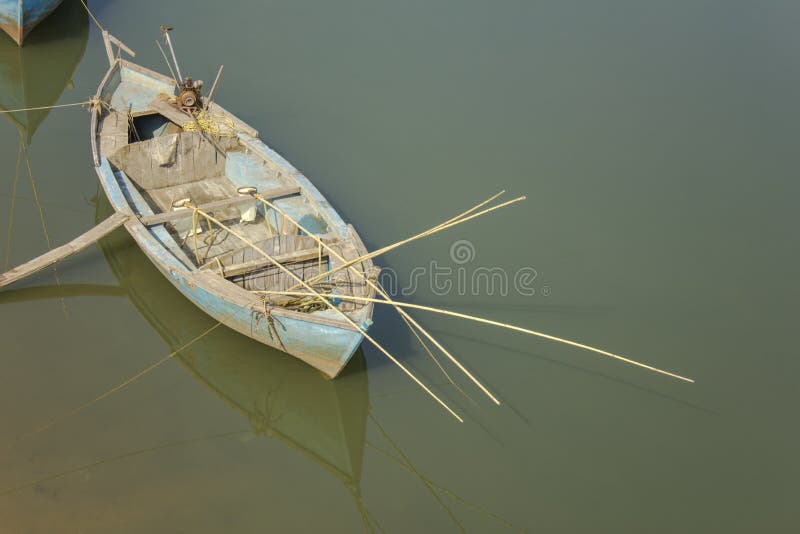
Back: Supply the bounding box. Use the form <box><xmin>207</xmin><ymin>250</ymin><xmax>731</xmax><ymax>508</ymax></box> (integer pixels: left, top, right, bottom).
<box><xmin>0</xmin><ymin>1</ymin><xmax>89</xmax><ymax>144</ymax></box>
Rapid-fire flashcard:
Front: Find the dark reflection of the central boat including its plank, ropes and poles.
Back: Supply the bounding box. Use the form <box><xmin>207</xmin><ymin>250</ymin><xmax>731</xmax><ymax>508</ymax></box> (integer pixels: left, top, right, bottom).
<box><xmin>0</xmin><ymin>198</ymin><xmax>520</xmax><ymax>531</ymax></box>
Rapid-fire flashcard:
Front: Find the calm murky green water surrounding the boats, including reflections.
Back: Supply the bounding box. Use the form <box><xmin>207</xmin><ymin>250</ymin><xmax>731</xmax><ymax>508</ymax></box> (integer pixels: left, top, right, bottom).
<box><xmin>0</xmin><ymin>0</ymin><xmax>800</xmax><ymax>534</ymax></box>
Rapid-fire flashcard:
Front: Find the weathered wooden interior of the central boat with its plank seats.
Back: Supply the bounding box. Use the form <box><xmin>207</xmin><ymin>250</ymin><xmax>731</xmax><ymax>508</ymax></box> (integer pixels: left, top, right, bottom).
<box><xmin>98</xmin><ymin>63</ymin><xmax>377</xmax><ymax>311</ymax></box>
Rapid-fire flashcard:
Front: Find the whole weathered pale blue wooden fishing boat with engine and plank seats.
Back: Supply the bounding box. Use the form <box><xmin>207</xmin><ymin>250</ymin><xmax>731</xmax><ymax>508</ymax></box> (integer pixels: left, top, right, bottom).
<box><xmin>91</xmin><ymin>34</ymin><xmax>377</xmax><ymax>378</ymax></box>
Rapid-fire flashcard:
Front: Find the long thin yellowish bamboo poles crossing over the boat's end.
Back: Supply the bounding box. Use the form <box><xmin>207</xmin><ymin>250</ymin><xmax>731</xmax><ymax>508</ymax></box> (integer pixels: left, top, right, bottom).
<box><xmin>178</xmin><ymin>191</ymin><xmax>694</xmax><ymax>421</ymax></box>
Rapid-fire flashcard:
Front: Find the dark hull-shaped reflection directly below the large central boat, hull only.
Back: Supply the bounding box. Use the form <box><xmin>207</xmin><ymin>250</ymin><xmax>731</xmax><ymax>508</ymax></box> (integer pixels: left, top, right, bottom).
<box><xmin>98</xmin><ymin>195</ymin><xmax>369</xmax><ymax>499</ymax></box>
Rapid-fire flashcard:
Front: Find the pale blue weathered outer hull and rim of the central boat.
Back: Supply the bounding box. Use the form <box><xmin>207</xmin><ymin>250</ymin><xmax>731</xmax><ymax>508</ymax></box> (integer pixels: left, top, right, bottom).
<box><xmin>92</xmin><ymin>56</ymin><xmax>372</xmax><ymax>378</ymax></box>
